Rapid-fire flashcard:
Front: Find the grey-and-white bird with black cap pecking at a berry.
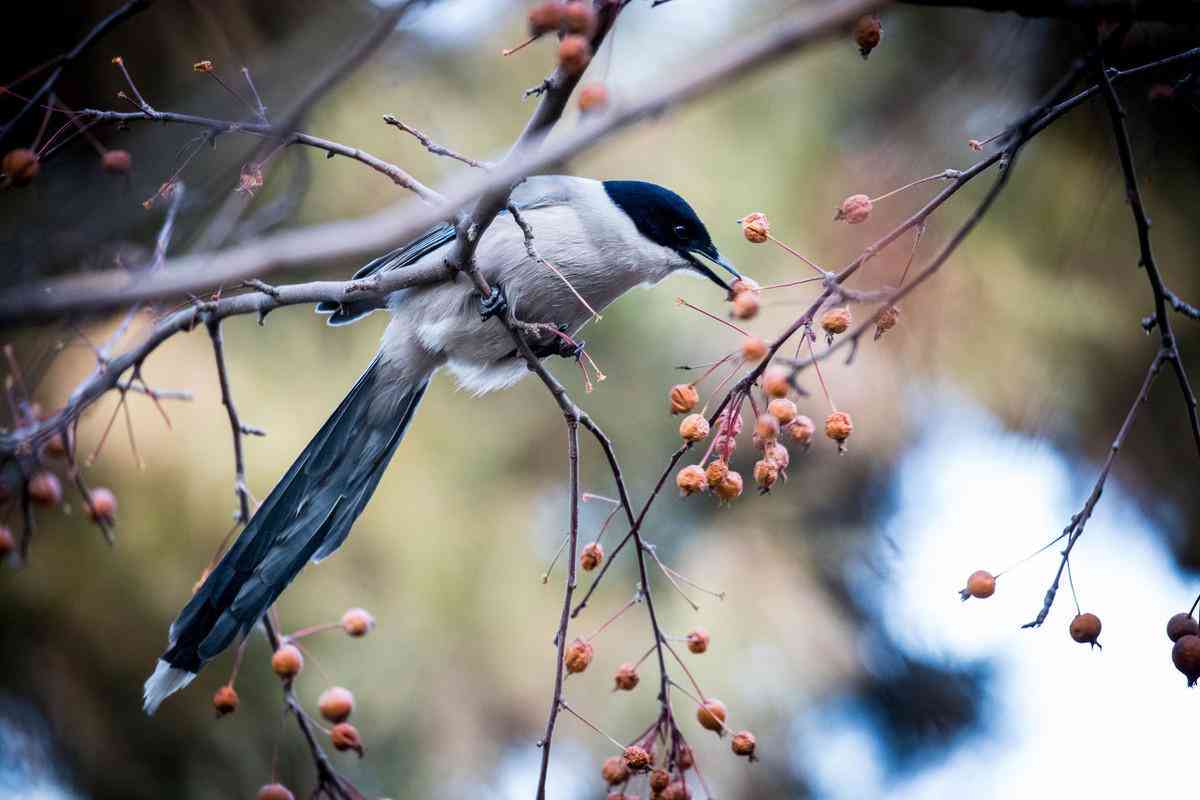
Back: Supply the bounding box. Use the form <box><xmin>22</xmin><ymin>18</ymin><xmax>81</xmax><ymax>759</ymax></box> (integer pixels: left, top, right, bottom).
<box><xmin>143</xmin><ymin>175</ymin><xmax>742</xmax><ymax>714</ymax></box>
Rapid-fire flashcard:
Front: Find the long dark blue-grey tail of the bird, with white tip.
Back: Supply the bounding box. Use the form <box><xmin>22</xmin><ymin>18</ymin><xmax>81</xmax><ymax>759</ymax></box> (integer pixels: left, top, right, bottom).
<box><xmin>144</xmin><ymin>356</ymin><xmax>428</xmax><ymax>714</ymax></box>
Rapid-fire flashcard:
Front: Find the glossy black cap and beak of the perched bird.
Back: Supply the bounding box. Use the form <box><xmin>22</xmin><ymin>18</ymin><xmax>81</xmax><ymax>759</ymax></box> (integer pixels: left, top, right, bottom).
<box><xmin>604</xmin><ymin>181</ymin><xmax>742</xmax><ymax>290</ymax></box>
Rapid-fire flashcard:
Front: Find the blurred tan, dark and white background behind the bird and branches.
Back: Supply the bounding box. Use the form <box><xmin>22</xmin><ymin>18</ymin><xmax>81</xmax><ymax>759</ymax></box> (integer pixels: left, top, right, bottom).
<box><xmin>0</xmin><ymin>0</ymin><xmax>1200</xmax><ymax>799</ymax></box>
